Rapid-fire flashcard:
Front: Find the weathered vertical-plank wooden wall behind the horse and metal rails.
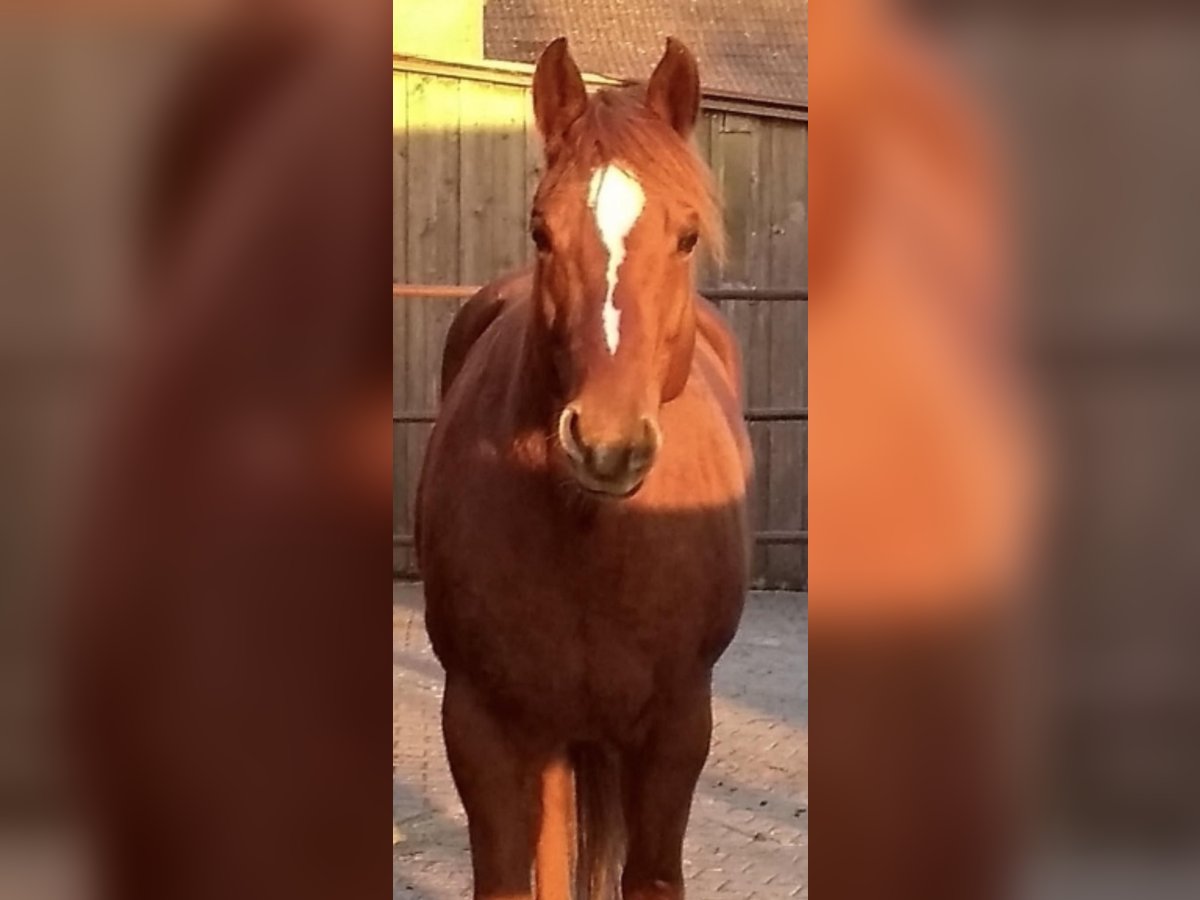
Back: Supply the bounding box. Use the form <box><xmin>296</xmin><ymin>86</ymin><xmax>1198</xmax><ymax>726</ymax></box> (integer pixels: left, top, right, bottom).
<box><xmin>392</xmin><ymin>71</ymin><xmax>808</xmax><ymax>588</ymax></box>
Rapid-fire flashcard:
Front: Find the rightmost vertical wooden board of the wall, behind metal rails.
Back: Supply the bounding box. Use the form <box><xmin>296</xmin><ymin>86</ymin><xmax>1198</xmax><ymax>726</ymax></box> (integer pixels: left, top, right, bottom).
<box><xmin>767</xmin><ymin>122</ymin><xmax>808</xmax><ymax>586</ymax></box>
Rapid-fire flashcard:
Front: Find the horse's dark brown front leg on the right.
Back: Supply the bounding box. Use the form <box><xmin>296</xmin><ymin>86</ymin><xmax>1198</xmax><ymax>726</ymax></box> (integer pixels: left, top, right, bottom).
<box><xmin>620</xmin><ymin>680</ymin><xmax>713</xmax><ymax>900</ymax></box>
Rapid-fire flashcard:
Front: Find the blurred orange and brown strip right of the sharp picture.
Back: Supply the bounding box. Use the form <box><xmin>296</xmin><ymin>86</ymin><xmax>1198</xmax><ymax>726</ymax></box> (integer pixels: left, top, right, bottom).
<box><xmin>809</xmin><ymin>2</ymin><xmax>1200</xmax><ymax>898</ymax></box>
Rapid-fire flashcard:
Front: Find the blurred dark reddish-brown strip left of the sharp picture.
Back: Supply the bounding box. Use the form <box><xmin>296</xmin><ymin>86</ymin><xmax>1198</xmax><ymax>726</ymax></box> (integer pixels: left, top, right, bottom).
<box><xmin>0</xmin><ymin>2</ymin><xmax>391</xmax><ymax>898</ymax></box>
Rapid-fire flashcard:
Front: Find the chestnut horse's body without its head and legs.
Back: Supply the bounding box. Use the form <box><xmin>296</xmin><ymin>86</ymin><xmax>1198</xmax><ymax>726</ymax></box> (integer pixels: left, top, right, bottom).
<box><xmin>420</xmin><ymin>278</ymin><xmax>749</xmax><ymax>742</ymax></box>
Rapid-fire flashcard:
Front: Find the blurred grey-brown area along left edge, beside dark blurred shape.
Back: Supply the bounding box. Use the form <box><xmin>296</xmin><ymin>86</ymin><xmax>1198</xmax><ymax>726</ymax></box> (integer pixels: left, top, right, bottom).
<box><xmin>0</xmin><ymin>19</ymin><xmax>191</xmax><ymax>896</ymax></box>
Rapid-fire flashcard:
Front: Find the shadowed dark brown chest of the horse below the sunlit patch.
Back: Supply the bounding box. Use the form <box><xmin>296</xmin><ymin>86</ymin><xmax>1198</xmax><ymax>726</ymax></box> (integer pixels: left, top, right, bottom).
<box><xmin>431</xmin><ymin>496</ymin><xmax>740</xmax><ymax>734</ymax></box>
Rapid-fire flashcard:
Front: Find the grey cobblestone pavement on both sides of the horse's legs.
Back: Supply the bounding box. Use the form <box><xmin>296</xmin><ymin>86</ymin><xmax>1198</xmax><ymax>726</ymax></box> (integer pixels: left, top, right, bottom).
<box><xmin>392</xmin><ymin>583</ymin><xmax>809</xmax><ymax>900</ymax></box>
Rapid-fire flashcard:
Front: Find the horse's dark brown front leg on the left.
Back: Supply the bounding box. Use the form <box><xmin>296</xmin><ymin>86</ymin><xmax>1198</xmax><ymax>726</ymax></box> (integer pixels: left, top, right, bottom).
<box><xmin>442</xmin><ymin>677</ymin><xmax>541</xmax><ymax>900</ymax></box>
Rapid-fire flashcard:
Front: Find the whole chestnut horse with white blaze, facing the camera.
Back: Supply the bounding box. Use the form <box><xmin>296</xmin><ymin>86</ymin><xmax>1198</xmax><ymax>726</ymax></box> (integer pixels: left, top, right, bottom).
<box><xmin>418</xmin><ymin>38</ymin><xmax>751</xmax><ymax>900</ymax></box>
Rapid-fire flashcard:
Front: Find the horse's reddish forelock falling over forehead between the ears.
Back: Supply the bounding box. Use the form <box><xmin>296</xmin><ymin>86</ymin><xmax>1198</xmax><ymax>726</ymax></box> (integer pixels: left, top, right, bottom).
<box><xmin>538</xmin><ymin>84</ymin><xmax>725</xmax><ymax>262</ymax></box>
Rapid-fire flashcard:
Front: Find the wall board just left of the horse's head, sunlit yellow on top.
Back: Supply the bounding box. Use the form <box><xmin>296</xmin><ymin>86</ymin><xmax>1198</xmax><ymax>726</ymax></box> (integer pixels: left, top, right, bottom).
<box><xmin>487</xmin><ymin>85</ymin><xmax>529</xmax><ymax>277</ymax></box>
